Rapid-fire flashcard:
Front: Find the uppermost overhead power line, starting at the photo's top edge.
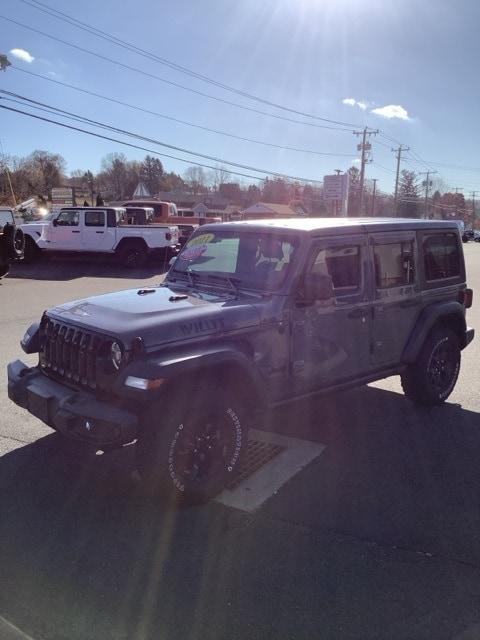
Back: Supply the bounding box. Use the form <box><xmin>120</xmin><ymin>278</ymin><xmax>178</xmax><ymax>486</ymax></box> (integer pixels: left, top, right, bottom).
<box><xmin>16</xmin><ymin>0</ymin><xmax>359</xmax><ymax>127</ymax></box>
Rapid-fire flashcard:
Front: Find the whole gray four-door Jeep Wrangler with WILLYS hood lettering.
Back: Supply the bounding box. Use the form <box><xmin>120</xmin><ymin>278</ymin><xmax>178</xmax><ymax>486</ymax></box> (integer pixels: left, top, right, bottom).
<box><xmin>8</xmin><ymin>218</ymin><xmax>474</xmax><ymax>501</ymax></box>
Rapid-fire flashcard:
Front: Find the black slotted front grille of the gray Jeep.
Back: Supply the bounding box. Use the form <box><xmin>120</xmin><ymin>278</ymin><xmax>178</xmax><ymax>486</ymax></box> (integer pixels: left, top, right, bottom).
<box><xmin>40</xmin><ymin>317</ymin><xmax>103</xmax><ymax>390</ymax></box>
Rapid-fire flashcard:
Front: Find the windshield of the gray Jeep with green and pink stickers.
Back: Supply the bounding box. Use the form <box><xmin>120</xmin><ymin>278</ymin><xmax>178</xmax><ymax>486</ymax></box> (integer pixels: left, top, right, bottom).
<box><xmin>169</xmin><ymin>230</ymin><xmax>296</xmax><ymax>291</ymax></box>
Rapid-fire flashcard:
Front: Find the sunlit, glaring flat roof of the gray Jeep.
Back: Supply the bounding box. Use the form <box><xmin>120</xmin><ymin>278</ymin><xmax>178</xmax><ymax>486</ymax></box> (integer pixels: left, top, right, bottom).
<box><xmin>201</xmin><ymin>218</ymin><xmax>458</xmax><ymax>236</ymax></box>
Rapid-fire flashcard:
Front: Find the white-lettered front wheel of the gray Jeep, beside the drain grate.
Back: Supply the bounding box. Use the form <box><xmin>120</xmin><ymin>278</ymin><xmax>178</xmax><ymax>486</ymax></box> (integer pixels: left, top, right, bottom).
<box><xmin>137</xmin><ymin>391</ymin><xmax>248</xmax><ymax>504</ymax></box>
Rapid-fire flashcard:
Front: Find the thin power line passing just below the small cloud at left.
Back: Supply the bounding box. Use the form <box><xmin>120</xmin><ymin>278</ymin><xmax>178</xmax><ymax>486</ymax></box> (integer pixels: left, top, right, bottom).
<box><xmin>11</xmin><ymin>65</ymin><xmax>352</xmax><ymax>158</ymax></box>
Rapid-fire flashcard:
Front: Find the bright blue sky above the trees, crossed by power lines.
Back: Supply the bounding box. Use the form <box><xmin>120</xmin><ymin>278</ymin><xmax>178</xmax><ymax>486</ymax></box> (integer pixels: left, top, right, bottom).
<box><xmin>0</xmin><ymin>0</ymin><xmax>480</xmax><ymax>195</ymax></box>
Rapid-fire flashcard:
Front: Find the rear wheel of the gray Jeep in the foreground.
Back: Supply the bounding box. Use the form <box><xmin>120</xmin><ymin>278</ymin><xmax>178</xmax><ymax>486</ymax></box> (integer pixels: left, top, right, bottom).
<box><xmin>402</xmin><ymin>328</ymin><xmax>460</xmax><ymax>406</ymax></box>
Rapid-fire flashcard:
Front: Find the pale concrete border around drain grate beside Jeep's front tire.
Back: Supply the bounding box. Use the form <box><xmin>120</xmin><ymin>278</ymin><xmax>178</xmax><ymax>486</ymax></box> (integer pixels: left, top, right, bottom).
<box><xmin>216</xmin><ymin>429</ymin><xmax>325</xmax><ymax>513</ymax></box>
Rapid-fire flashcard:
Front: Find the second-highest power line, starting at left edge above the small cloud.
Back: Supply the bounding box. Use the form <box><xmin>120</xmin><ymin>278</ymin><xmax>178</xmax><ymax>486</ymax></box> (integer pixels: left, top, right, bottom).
<box><xmin>0</xmin><ymin>15</ymin><xmax>360</xmax><ymax>131</ymax></box>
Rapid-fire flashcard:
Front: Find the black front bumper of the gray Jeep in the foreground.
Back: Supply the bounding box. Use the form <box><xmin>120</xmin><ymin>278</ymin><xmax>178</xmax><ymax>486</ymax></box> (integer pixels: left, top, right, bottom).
<box><xmin>8</xmin><ymin>360</ymin><xmax>138</xmax><ymax>448</ymax></box>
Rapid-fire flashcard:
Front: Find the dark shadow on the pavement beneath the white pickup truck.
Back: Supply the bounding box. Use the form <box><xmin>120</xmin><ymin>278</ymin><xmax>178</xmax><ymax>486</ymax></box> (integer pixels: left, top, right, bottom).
<box><xmin>5</xmin><ymin>257</ymin><xmax>168</xmax><ymax>282</ymax></box>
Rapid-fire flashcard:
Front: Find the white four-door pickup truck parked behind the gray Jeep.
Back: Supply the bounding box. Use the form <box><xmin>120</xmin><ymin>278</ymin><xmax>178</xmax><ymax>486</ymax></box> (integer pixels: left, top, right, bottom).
<box><xmin>21</xmin><ymin>207</ymin><xmax>180</xmax><ymax>268</ymax></box>
